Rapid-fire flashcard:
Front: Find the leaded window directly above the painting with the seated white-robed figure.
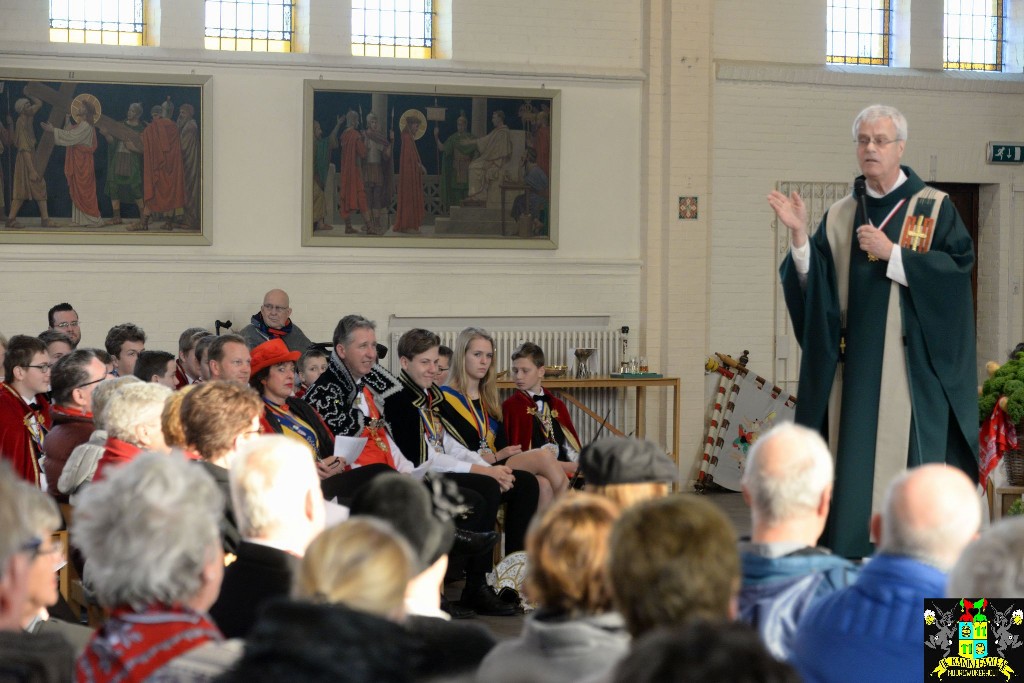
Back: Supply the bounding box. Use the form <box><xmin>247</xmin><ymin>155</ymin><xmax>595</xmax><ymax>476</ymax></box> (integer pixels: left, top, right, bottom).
<box><xmin>352</xmin><ymin>0</ymin><xmax>434</xmax><ymax>59</ymax></box>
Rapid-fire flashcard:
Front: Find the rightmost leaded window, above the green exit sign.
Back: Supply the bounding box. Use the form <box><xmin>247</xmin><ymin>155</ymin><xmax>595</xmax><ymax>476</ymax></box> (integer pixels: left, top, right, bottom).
<box><xmin>942</xmin><ymin>0</ymin><xmax>1002</xmax><ymax>71</ymax></box>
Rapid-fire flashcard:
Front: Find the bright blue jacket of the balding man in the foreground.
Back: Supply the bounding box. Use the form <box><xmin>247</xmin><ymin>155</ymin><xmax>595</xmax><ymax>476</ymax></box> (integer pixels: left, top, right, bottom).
<box><xmin>790</xmin><ymin>555</ymin><xmax>946</xmax><ymax>683</ymax></box>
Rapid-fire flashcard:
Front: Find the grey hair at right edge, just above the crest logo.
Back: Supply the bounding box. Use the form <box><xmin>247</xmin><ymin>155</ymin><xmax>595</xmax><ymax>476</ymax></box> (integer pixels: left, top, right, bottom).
<box><xmin>946</xmin><ymin>517</ymin><xmax>1024</xmax><ymax>598</ymax></box>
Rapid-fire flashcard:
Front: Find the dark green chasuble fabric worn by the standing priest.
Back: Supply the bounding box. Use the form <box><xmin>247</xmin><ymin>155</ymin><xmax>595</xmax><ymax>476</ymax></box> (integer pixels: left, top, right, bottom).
<box><xmin>779</xmin><ymin>166</ymin><xmax>978</xmax><ymax>557</ymax></box>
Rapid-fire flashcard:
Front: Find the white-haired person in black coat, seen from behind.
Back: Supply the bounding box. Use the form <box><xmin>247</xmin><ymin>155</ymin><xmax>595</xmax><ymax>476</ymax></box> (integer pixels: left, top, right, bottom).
<box><xmin>210</xmin><ymin>434</ymin><xmax>325</xmax><ymax>638</ymax></box>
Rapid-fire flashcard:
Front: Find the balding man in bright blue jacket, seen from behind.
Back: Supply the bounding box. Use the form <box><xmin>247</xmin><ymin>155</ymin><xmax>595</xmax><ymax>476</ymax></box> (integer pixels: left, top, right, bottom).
<box><xmin>791</xmin><ymin>464</ymin><xmax>981</xmax><ymax>683</ymax></box>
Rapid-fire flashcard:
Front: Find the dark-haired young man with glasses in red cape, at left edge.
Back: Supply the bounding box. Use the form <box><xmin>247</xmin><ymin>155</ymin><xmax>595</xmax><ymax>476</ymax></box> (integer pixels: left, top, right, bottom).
<box><xmin>0</xmin><ymin>335</ymin><xmax>51</xmax><ymax>488</ymax></box>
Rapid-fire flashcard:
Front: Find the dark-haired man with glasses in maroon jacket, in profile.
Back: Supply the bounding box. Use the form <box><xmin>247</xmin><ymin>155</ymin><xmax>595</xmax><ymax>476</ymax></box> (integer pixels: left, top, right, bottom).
<box><xmin>43</xmin><ymin>348</ymin><xmax>106</xmax><ymax>503</ymax></box>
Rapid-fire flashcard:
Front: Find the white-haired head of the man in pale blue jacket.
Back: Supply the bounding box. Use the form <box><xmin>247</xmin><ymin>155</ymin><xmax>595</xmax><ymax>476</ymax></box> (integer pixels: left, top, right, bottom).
<box><xmin>741</xmin><ymin>422</ymin><xmax>835</xmax><ymax>524</ymax></box>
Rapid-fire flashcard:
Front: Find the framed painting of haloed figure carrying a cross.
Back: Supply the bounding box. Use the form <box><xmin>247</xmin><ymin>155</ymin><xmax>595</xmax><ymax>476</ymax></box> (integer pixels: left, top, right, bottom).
<box><xmin>0</xmin><ymin>69</ymin><xmax>211</xmax><ymax>245</ymax></box>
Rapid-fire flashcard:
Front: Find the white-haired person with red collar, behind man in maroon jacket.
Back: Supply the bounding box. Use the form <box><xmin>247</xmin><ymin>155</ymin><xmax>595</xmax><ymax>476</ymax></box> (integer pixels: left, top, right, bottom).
<box><xmin>93</xmin><ymin>382</ymin><xmax>173</xmax><ymax>481</ymax></box>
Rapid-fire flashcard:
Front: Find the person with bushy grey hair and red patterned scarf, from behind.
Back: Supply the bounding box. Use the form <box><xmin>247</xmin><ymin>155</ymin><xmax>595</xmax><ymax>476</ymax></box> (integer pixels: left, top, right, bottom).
<box><xmin>72</xmin><ymin>453</ymin><xmax>232</xmax><ymax>683</ymax></box>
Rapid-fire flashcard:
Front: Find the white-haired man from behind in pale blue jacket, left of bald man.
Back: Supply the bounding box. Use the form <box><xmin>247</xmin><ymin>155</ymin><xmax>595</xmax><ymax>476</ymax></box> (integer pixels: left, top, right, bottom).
<box><xmin>739</xmin><ymin>422</ymin><xmax>857</xmax><ymax>660</ymax></box>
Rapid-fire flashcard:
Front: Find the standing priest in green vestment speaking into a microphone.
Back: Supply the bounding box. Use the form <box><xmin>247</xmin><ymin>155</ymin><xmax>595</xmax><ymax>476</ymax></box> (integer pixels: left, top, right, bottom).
<box><xmin>768</xmin><ymin>105</ymin><xmax>978</xmax><ymax>557</ymax></box>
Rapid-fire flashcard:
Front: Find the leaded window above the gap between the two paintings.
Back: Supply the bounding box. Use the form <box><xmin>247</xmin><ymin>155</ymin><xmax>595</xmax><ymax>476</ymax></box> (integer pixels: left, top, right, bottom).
<box><xmin>205</xmin><ymin>0</ymin><xmax>295</xmax><ymax>52</ymax></box>
